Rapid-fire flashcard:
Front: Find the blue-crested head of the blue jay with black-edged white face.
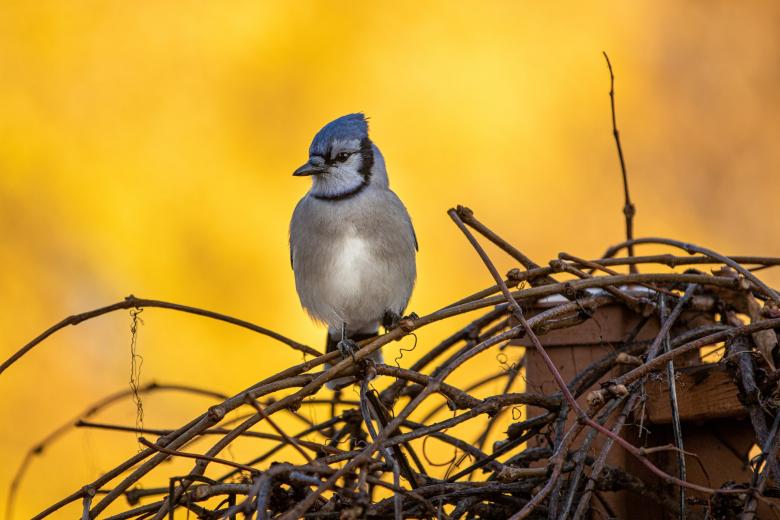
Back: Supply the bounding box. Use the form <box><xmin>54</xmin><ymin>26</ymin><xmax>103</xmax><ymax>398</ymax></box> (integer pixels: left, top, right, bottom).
<box><xmin>293</xmin><ymin>114</ymin><xmax>387</xmax><ymax>200</ymax></box>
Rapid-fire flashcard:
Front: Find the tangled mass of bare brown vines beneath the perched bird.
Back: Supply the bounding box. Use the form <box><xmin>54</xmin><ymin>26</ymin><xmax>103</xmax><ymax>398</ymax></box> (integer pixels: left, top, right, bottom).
<box><xmin>6</xmin><ymin>207</ymin><xmax>780</xmax><ymax>519</ymax></box>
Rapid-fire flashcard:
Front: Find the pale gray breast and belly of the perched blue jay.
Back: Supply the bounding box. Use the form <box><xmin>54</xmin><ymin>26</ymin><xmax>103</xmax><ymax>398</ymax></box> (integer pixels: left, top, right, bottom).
<box><xmin>290</xmin><ymin>189</ymin><xmax>416</xmax><ymax>332</ymax></box>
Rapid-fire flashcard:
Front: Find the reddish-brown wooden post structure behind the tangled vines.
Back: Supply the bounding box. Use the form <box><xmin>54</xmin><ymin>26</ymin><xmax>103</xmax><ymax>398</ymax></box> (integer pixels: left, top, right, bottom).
<box><xmin>511</xmin><ymin>289</ymin><xmax>756</xmax><ymax>520</ymax></box>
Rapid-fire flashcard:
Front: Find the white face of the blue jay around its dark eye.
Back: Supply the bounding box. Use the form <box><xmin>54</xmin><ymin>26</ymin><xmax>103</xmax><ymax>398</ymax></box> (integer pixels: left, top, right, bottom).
<box><xmin>309</xmin><ymin>139</ymin><xmax>368</xmax><ymax>197</ymax></box>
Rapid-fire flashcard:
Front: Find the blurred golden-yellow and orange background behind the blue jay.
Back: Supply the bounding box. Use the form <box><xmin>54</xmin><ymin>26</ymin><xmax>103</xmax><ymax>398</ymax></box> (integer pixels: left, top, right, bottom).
<box><xmin>0</xmin><ymin>0</ymin><xmax>780</xmax><ymax>518</ymax></box>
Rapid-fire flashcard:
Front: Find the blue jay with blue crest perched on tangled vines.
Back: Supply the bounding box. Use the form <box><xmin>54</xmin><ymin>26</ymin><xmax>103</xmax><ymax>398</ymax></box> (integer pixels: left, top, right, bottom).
<box><xmin>290</xmin><ymin>113</ymin><xmax>418</xmax><ymax>389</ymax></box>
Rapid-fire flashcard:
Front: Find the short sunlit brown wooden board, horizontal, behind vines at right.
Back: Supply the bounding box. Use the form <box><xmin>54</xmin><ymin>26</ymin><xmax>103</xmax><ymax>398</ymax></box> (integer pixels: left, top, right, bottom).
<box><xmin>645</xmin><ymin>365</ymin><xmax>747</xmax><ymax>424</ymax></box>
